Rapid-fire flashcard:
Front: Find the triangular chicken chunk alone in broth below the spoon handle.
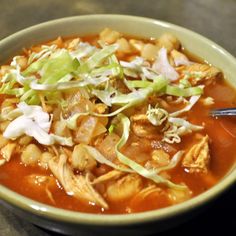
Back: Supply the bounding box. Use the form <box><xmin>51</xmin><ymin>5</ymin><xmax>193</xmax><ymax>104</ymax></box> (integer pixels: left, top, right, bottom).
<box><xmin>182</xmin><ymin>135</ymin><xmax>210</xmax><ymax>173</ymax></box>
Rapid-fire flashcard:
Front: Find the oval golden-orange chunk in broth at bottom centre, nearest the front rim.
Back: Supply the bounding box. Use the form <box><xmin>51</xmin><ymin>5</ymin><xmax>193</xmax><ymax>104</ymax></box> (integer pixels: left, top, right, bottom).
<box><xmin>106</xmin><ymin>174</ymin><xmax>143</xmax><ymax>202</ymax></box>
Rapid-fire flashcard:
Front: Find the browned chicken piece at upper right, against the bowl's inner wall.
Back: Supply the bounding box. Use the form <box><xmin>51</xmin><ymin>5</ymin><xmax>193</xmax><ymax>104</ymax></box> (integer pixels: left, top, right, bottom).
<box><xmin>184</xmin><ymin>63</ymin><xmax>222</xmax><ymax>85</ymax></box>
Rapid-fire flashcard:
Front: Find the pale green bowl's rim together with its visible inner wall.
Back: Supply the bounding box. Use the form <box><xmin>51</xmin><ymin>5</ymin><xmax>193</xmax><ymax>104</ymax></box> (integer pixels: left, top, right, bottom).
<box><xmin>0</xmin><ymin>15</ymin><xmax>236</xmax><ymax>225</ymax></box>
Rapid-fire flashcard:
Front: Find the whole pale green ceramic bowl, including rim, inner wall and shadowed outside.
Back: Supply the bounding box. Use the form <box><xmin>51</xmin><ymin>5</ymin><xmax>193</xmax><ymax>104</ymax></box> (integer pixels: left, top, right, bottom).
<box><xmin>0</xmin><ymin>15</ymin><xmax>236</xmax><ymax>236</ymax></box>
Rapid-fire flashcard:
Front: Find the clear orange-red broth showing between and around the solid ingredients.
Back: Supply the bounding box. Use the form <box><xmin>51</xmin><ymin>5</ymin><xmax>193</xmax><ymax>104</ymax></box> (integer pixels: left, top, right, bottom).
<box><xmin>0</xmin><ymin>36</ymin><xmax>236</xmax><ymax>214</ymax></box>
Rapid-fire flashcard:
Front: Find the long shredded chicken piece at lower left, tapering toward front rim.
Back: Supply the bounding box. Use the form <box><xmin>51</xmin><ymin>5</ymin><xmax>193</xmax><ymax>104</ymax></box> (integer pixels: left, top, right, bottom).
<box><xmin>48</xmin><ymin>154</ymin><xmax>108</xmax><ymax>209</ymax></box>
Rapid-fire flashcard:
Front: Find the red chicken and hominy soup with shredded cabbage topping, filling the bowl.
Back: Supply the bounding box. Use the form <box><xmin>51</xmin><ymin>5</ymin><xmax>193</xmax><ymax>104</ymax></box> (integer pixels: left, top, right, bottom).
<box><xmin>0</xmin><ymin>29</ymin><xmax>236</xmax><ymax>214</ymax></box>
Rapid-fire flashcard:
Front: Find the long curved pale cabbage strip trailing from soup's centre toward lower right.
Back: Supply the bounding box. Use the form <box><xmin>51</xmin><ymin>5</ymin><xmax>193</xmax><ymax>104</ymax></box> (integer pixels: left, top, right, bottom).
<box><xmin>115</xmin><ymin>114</ymin><xmax>186</xmax><ymax>190</ymax></box>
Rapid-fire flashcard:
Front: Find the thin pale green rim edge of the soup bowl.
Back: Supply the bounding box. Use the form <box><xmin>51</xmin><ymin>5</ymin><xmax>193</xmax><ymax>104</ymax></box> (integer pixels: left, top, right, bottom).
<box><xmin>0</xmin><ymin>14</ymin><xmax>236</xmax><ymax>227</ymax></box>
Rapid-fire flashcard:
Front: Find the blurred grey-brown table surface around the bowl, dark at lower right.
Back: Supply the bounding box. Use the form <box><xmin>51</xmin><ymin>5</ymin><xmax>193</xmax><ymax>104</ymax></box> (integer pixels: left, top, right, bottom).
<box><xmin>0</xmin><ymin>0</ymin><xmax>236</xmax><ymax>236</ymax></box>
